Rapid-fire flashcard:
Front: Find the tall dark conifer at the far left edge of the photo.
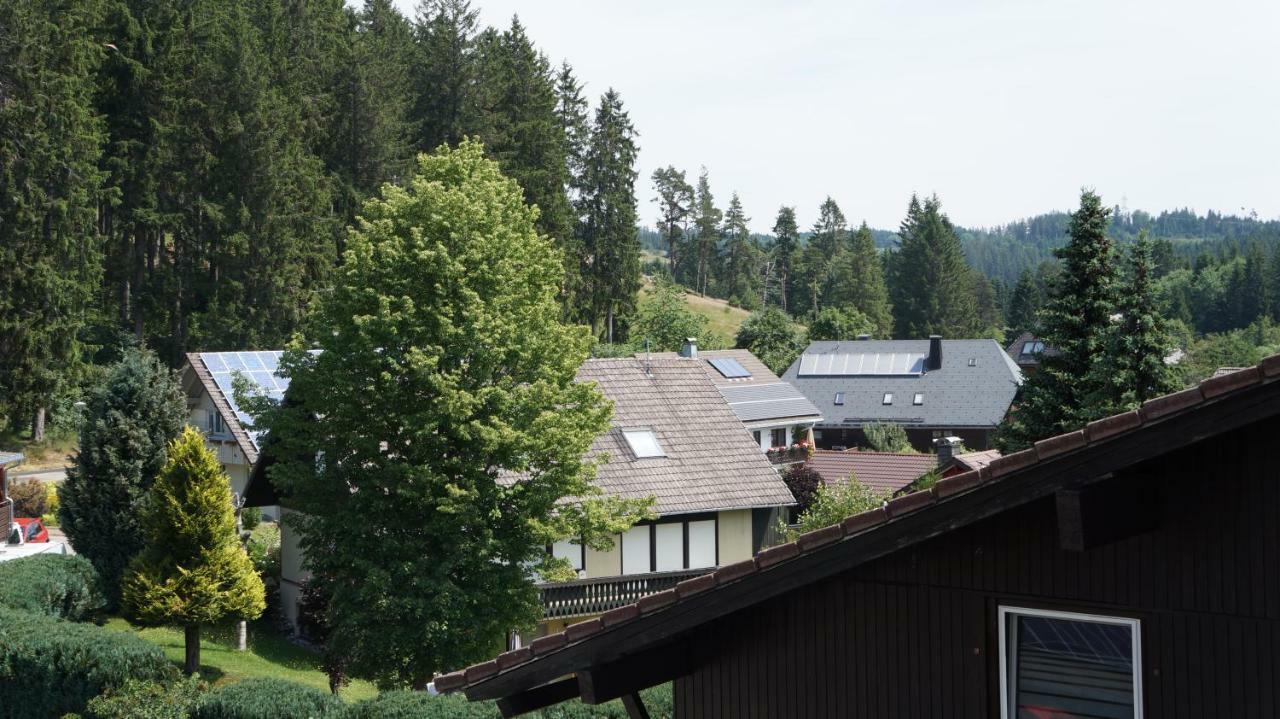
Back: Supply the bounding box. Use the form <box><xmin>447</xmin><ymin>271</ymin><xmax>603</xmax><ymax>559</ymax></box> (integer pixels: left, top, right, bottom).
<box><xmin>0</xmin><ymin>0</ymin><xmax>109</xmax><ymax>441</ymax></box>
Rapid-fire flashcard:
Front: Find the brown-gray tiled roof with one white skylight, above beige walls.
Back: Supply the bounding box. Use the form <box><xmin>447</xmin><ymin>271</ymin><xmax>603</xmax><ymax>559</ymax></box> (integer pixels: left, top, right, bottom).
<box><xmin>577</xmin><ymin>357</ymin><xmax>795</xmax><ymax>514</ymax></box>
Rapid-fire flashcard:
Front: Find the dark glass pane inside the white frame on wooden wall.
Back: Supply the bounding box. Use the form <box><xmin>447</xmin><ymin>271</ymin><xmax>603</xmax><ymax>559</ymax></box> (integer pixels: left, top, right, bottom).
<box><xmin>1010</xmin><ymin>614</ymin><xmax>1134</xmax><ymax>719</ymax></box>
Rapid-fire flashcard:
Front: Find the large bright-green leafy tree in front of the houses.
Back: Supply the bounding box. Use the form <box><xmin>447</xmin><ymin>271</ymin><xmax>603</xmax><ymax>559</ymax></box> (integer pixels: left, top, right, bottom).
<box><xmin>247</xmin><ymin>141</ymin><xmax>650</xmax><ymax>688</ymax></box>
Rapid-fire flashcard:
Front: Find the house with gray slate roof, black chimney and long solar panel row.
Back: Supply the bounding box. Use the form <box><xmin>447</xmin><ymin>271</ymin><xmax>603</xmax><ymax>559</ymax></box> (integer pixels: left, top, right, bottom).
<box><xmin>782</xmin><ymin>335</ymin><xmax>1021</xmax><ymax>452</ymax></box>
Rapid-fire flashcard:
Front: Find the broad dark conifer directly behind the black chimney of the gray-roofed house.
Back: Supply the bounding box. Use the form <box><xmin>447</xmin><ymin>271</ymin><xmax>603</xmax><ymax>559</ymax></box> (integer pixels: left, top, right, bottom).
<box><xmin>890</xmin><ymin>190</ymin><xmax>983</xmax><ymax>338</ymax></box>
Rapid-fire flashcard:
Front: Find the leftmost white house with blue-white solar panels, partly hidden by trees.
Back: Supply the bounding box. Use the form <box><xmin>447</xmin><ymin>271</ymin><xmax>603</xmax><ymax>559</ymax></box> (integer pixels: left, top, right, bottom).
<box><xmin>179</xmin><ymin>352</ymin><xmax>289</xmax><ymax>496</ymax></box>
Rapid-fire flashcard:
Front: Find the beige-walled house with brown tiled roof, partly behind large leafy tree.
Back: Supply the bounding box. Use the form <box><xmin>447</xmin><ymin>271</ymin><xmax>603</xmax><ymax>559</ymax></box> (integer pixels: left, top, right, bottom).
<box><xmin>246</xmin><ymin>357</ymin><xmax>795</xmax><ymax>633</ymax></box>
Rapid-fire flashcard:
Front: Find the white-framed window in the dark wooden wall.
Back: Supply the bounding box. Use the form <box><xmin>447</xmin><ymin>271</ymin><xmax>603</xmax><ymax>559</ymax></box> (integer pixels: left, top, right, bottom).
<box><xmin>1000</xmin><ymin>606</ymin><xmax>1142</xmax><ymax>719</ymax></box>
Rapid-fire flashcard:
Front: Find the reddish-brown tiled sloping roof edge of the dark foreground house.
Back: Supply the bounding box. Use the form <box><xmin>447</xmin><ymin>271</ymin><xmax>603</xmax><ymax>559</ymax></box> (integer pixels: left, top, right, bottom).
<box><xmin>435</xmin><ymin>354</ymin><xmax>1280</xmax><ymax>693</ymax></box>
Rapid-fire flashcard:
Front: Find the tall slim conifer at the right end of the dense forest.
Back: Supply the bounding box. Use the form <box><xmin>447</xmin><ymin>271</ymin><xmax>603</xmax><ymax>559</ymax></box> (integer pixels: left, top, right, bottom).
<box><xmin>580</xmin><ymin>90</ymin><xmax>640</xmax><ymax>343</ymax></box>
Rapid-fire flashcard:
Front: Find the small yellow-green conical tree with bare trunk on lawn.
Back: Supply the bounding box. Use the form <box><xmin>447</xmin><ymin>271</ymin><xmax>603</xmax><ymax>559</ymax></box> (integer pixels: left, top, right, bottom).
<box><xmin>123</xmin><ymin>427</ymin><xmax>266</xmax><ymax>674</ymax></box>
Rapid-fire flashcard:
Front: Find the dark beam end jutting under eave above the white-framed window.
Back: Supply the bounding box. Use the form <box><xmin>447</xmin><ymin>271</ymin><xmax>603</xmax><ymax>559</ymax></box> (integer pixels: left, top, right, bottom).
<box><xmin>1055</xmin><ymin>475</ymin><xmax>1164</xmax><ymax>551</ymax></box>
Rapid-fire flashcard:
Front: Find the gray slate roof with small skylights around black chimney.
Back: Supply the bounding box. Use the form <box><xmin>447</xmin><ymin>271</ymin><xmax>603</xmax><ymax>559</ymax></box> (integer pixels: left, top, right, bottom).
<box><xmin>782</xmin><ymin>339</ymin><xmax>1021</xmax><ymax>427</ymax></box>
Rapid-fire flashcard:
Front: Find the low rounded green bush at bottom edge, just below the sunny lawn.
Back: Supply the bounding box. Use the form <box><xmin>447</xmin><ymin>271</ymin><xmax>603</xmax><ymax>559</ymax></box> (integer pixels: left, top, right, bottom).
<box><xmin>191</xmin><ymin>679</ymin><xmax>346</xmax><ymax>719</ymax></box>
